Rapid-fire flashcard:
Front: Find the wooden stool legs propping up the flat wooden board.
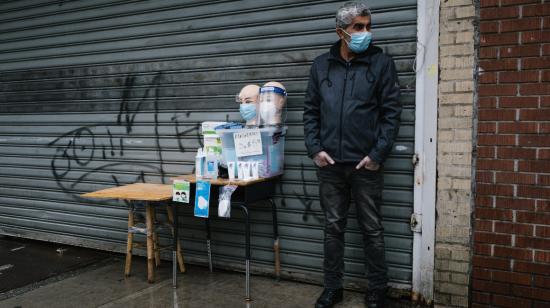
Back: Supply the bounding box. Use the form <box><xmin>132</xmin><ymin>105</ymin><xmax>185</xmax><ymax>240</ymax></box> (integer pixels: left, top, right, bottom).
<box><xmin>124</xmin><ymin>202</ymin><xmax>185</xmax><ymax>283</ymax></box>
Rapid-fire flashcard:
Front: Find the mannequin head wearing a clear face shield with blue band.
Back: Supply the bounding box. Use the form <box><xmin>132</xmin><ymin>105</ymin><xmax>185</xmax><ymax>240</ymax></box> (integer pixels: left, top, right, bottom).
<box><xmin>260</xmin><ymin>81</ymin><xmax>287</xmax><ymax>125</ymax></box>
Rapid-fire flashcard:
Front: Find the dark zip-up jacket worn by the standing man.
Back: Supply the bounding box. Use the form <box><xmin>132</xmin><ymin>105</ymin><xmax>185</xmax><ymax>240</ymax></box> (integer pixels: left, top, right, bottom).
<box><xmin>304</xmin><ymin>42</ymin><xmax>401</xmax><ymax>163</ymax></box>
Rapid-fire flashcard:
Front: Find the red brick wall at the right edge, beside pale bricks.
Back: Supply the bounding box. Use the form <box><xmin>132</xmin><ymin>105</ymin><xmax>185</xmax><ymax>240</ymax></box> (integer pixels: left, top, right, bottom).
<box><xmin>471</xmin><ymin>0</ymin><xmax>550</xmax><ymax>308</ymax></box>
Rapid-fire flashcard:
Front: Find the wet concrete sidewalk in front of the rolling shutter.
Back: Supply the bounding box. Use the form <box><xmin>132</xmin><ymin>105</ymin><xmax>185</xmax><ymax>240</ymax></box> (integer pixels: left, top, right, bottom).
<box><xmin>0</xmin><ymin>257</ymin><xmax>424</xmax><ymax>308</ymax></box>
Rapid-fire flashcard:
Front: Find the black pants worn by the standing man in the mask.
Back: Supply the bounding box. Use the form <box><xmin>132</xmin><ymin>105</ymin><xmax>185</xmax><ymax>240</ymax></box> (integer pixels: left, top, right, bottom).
<box><xmin>317</xmin><ymin>163</ymin><xmax>388</xmax><ymax>290</ymax></box>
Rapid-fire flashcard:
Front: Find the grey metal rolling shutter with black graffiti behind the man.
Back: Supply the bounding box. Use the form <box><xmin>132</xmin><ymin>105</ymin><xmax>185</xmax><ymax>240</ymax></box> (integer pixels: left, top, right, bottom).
<box><xmin>0</xmin><ymin>0</ymin><xmax>417</xmax><ymax>288</ymax></box>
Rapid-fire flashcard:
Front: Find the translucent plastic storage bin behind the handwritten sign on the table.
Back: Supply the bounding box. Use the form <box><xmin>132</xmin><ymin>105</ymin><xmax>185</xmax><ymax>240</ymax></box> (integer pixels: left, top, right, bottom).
<box><xmin>216</xmin><ymin>126</ymin><xmax>287</xmax><ymax>178</ymax></box>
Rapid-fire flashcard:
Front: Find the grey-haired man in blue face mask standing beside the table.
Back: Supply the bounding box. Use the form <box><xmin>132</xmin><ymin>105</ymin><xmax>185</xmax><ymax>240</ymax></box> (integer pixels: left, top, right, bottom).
<box><xmin>304</xmin><ymin>2</ymin><xmax>401</xmax><ymax>308</ymax></box>
